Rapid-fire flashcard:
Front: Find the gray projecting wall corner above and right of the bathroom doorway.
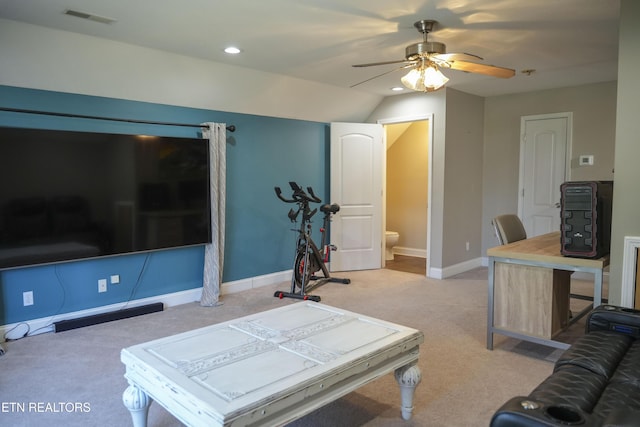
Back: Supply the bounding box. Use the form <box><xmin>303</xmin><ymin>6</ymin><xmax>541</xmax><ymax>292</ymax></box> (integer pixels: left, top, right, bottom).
<box><xmin>368</xmin><ymin>88</ymin><xmax>484</xmax><ymax>277</ymax></box>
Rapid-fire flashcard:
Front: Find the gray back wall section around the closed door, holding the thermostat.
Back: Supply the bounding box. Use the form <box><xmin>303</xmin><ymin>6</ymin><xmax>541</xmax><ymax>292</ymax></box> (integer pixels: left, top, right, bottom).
<box><xmin>482</xmin><ymin>82</ymin><xmax>617</xmax><ymax>254</ymax></box>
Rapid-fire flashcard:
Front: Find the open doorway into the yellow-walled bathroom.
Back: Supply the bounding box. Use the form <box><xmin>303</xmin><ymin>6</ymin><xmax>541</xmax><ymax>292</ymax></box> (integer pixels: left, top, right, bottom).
<box><xmin>383</xmin><ymin>119</ymin><xmax>431</xmax><ymax>275</ymax></box>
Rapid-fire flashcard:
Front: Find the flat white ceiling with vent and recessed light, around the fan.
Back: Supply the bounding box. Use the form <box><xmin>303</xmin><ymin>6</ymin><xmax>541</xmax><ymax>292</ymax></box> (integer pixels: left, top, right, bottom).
<box><xmin>0</xmin><ymin>0</ymin><xmax>620</xmax><ymax>96</ymax></box>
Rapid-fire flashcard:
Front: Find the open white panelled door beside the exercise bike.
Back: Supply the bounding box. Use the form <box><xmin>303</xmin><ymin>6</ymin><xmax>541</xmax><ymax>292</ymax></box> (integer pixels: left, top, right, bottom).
<box><xmin>330</xmin><ymin>123</ymin><xmax>384</xmax><ymax>271</ymax></box>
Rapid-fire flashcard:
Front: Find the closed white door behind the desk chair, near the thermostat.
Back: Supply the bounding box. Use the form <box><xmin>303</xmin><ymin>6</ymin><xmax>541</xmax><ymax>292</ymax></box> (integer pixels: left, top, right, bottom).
<box><xmin>518</xmin><ymin>113</ymin><xmax>571</xmax><ymax>237</ymax></box>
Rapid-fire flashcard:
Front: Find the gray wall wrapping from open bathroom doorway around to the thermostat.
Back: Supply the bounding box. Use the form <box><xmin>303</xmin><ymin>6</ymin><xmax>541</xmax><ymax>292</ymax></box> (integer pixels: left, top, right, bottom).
<box><xmin>368</xmin><ymin>82</ymin><xmax>617</xmax><ymax>277</ymax></box>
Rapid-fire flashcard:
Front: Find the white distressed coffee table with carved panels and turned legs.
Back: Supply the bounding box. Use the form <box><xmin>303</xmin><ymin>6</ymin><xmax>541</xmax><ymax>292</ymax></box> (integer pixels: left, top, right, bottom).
<box><xmin>121</xmin><ymin>301</ymin><xmax>424</xmax><ymax>427</ymax></box>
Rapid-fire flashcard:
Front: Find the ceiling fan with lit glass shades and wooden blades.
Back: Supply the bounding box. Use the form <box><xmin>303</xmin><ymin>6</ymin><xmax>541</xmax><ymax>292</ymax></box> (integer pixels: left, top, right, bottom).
<box><xmin>351</xmin><ymin>19</ymin><xmax>515</xmax><ymax>92</ymax></box>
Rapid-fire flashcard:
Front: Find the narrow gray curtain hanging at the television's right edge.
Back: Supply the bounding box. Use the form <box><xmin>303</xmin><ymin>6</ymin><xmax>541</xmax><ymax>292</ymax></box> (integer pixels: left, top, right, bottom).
<box><xmin>200</xmin><ymin>123</ymin><xmax>227</xmax><ymax>307</ymax></box>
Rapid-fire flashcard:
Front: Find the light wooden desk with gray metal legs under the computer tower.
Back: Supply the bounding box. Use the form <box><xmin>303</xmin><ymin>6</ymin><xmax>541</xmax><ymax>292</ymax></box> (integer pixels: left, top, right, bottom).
<box><xmin>487</xmin><ymin>232</ymin><xmax>609</xmax><ymax>350</ymax></box>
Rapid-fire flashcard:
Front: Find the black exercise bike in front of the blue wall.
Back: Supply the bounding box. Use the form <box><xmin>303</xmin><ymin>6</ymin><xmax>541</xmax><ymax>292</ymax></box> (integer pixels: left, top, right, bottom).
<box><xmin>274</xmin><ymin>182</ymin><xmax>351</xmax><ymax>302</ymax></box>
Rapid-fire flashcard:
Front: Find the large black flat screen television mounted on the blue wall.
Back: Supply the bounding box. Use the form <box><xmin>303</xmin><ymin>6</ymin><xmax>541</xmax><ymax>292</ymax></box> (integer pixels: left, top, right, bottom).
<box><xmin>0</xmin><ymin>127</ymin><xmax>211</xmax><ymax>269</ymax></box>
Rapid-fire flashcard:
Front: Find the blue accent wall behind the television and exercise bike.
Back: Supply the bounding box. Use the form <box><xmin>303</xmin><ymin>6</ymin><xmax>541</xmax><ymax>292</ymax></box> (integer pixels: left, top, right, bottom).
<box><xmin>0</xmin><ymin>86</ymin><xmax>329</xmax><ymax>325</ymax></box>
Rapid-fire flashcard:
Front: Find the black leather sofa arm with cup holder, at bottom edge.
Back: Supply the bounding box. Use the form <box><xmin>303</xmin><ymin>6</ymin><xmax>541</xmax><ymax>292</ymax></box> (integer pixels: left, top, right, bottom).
<box><xmin>491</xmin><ymin>396</ymin><xmax>598</xmax><ymax>427</ymax></box>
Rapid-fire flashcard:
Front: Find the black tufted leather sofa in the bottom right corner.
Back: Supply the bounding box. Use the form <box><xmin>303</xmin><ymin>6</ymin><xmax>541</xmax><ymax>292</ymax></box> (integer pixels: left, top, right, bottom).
<box><xmin>491</xmin><ymin>305</ymin><xmax>640</xmax><ymax>427</ymax></box>
